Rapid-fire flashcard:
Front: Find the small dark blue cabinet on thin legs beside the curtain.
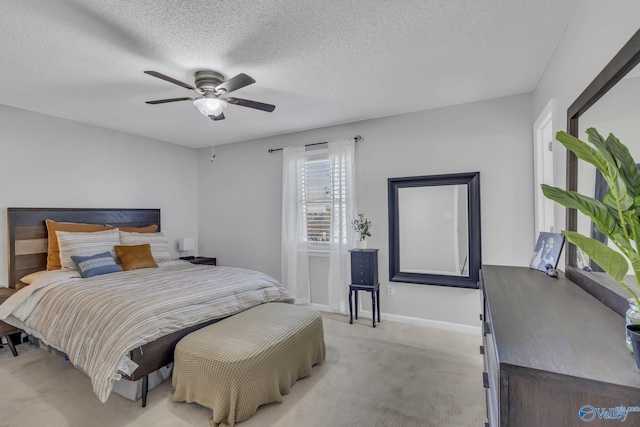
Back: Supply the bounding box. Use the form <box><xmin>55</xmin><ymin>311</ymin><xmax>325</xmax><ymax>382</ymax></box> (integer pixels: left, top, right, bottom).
<box><xmin>349</xmin><ymin>249</ymin><xmax>380</xmax><ymax>328</ymax></box>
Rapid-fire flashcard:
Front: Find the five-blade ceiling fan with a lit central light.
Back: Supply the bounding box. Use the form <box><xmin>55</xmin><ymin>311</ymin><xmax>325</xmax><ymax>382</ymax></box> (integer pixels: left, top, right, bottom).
<box><xmin>145</xmin><ymin>70</ymin><xmax>276</xmax><ymax>120</ymax></box>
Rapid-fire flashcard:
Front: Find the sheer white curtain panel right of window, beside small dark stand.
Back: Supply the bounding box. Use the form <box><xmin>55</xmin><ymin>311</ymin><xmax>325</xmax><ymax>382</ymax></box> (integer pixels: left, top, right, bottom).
<box><xmin>328</xmin><ymin>139</ymin><xmax>357</xmax><ymax>313</ymax></box>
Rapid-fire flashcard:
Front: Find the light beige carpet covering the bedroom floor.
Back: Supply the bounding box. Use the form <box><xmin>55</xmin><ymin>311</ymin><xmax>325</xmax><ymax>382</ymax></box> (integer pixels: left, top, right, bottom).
<box><xmin>0</xmin><ymin>313</ymin><xmax>485</xmax><ymax>427</ymax></box>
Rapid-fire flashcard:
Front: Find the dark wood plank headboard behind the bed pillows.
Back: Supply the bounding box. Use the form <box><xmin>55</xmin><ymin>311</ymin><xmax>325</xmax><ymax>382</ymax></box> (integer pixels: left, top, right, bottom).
<box><xmin>7</xmin><ymin>208</ymin><xmax>160</xmax><ymax>288</ymax></box>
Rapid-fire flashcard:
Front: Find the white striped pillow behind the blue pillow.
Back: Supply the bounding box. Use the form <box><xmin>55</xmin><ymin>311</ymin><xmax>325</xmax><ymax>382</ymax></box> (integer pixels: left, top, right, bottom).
<box><xmin>56</xmin><ymin>228</ymin><xmax>120</xmax><ymax>270</ymax></box>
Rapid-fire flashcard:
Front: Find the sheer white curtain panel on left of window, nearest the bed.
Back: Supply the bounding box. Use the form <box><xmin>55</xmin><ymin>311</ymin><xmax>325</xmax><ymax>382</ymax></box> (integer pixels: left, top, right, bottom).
<box><xmin>281</xmin><ymin>147</ymin><xmax>311</xmax><ymax>304</ymax></box>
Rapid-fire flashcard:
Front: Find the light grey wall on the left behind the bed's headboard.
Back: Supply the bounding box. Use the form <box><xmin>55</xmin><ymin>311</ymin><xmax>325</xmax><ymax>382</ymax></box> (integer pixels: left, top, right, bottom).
<box><xmin>0</xmin><ymin>105</ymin><xmax>198</xmax><ymax>286</ymax></box>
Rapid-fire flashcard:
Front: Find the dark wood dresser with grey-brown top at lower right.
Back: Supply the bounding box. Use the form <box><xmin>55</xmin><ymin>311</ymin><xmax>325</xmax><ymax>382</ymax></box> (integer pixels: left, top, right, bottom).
<box><xmin>481</xmin><ymin>265</ymin><xmax>640</xmax><ymax>427</ymax></box>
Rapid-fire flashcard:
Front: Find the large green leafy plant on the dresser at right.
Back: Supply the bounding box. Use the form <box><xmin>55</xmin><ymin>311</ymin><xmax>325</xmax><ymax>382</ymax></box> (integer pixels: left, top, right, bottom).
<box><xmin>542</xmin><ymin>128</ymin><xmax>640</xmax><ymax>307</ymax></box>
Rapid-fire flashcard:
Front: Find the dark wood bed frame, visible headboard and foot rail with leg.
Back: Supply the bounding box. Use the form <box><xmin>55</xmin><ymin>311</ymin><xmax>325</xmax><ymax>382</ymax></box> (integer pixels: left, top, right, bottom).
<box><xmin>7</xmin><ymin>208</ymin><xmax>219</xmax><ymax>407</ymax></box>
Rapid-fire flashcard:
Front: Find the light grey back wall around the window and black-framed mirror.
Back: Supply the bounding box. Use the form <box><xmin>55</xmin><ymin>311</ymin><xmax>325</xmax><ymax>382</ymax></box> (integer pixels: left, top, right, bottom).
<box><xmin>198</xmin><ymin>94</ymin><xmax>535</xmax><ymax>326</ymax></box>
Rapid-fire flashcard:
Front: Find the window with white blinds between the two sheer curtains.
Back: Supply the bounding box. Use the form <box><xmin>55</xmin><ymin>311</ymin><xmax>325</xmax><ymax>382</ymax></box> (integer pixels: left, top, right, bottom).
<box><xmin>300</xmin><ymin>156</ymin><xmax>331</xmax><ymax>249</ymax></box>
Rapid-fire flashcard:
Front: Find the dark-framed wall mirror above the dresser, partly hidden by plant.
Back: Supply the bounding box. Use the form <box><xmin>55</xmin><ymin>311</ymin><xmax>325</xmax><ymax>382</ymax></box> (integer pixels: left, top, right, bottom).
<box><xmin>565</xmin><ymin>26</ymin><xmax>640</xmax><ymax>315</ymax></box>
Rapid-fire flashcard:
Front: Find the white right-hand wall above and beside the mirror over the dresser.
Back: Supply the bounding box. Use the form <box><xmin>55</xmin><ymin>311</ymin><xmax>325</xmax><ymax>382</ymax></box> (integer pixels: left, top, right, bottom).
<box><xmin>533</xmin><ymin>0</ymin><xmax>640</xmax><ymax>247</ymax></box>
